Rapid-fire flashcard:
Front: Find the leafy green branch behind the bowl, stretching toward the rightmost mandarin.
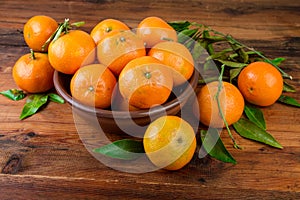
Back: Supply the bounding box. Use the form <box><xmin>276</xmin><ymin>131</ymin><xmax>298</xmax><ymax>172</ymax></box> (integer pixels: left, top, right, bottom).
<box><xmin>169</xmin><ymin>21</ymin><xmax>292</xmax><ymax>81</ymax></box>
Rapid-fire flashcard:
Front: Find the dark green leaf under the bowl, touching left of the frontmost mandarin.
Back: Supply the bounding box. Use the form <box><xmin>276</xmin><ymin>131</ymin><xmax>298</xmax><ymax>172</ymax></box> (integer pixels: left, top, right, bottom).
<box><xmin>93</xmin><ymin>139</ymin><xmax>145</xmax><ymax>160</ymax></box>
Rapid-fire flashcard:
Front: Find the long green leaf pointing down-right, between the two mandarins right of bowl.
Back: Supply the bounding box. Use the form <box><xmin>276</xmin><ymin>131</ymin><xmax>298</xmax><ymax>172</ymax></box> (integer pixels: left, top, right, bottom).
<box><xmin>233</xmin><ymin>118</ymin><xmax>282</xmax><ymax>149</ymax></box>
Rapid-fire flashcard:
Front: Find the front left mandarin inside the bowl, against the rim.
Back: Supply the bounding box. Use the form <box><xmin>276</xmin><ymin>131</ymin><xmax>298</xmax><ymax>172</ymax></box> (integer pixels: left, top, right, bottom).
<box><xmin>70</xmin><ymin>64</ymin><xmax>117</xmax><ymax>108</ymax></box>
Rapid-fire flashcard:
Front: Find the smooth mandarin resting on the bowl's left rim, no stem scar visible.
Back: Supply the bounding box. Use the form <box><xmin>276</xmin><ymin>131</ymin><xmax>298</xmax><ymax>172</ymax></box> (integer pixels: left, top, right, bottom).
<box><xmin>48</xmin><ymin>30</ymin><xmax>96</xmax><ymax>74</ymax></box>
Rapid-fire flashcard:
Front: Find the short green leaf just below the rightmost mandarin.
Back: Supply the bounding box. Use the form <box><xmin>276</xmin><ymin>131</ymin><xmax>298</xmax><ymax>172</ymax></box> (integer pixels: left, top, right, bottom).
<box><xmin>244</xmin><ymin>104</ymin><xmax>266</xmax><ymax>130</ymax></box>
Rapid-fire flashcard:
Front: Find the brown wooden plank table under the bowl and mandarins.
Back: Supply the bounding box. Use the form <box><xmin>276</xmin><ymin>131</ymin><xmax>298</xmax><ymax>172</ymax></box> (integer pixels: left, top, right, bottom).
<box><xmin>0</xmin><ymin>0</ymin><xmax>300</xmax><ymax>200</ymax></box>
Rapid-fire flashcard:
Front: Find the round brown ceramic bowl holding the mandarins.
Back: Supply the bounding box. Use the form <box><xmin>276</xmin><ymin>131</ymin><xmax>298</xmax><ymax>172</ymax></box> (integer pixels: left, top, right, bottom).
<box><xmin>54</xmin><ymin>70</ymin><xmax>199</xmax><ymax>135</ymax></box>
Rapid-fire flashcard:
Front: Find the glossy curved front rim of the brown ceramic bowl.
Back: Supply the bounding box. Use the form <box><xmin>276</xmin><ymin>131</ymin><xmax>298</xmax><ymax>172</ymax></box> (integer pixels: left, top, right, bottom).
<box><xmin>53</xmin><ymin>69</ymin><xmax>199</xmax><ymax>119</ymax></box>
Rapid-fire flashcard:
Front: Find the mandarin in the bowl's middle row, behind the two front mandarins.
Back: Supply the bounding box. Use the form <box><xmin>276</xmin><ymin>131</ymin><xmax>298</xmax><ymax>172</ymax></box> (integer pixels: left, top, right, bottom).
<box><xmin>97</xmin><ymin>30</ymin><xmax>146</xmax><ymax>76</ymax></box>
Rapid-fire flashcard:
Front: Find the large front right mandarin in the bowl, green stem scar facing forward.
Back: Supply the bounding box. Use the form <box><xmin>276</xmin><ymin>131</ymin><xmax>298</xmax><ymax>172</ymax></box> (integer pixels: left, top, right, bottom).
<box><xmin>119</xmin><ymin>56</ymin><xmax>173</xmax><ymax>109</ymax></box>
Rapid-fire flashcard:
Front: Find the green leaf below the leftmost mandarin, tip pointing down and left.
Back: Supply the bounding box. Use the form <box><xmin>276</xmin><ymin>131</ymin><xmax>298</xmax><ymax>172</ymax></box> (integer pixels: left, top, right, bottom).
<box><xmin>20</xmin><ymin>94</ymin><xmax>48</xmax><ymax>120</ymax></box>
